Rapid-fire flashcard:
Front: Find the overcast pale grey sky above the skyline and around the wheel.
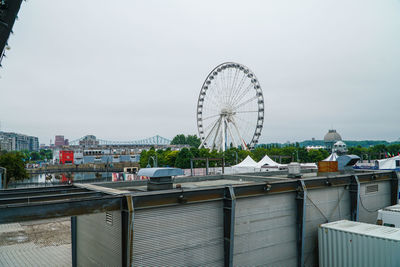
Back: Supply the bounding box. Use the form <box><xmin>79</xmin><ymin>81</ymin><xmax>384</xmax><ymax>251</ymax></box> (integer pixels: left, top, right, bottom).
<box><xmin>0</xmin><ymin>0</ymin><xmax>400</xmax><ymax>143</ymax></box>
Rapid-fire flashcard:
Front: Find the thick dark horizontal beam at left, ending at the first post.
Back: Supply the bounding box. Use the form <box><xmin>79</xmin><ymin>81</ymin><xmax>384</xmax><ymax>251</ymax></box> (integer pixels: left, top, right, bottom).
<box><xmin>0</xmin><ymin>196</ymin><xmax>124</xmax><ymax>224</ymax></box>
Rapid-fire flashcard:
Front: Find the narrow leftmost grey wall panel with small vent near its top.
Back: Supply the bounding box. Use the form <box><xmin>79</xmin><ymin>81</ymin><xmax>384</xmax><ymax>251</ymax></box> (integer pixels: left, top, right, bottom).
<box><xmin>76</xmin><ymin>211</ymin><xmax>122</xmax><ymax>267</ymax></box>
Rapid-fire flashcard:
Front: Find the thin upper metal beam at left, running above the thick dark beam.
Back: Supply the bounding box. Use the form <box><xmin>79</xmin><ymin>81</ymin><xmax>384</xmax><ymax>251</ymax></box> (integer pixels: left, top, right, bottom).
<box><xmin>0</xmin><ymin>191</ymin><xmax>104</xmax><ymax>207</ymax></box>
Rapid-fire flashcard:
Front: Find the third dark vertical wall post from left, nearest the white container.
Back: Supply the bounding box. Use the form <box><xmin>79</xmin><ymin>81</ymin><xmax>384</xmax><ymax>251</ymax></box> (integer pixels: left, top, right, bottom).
<box><xmin>296</xmin><ymin>180</ymin><xmax>307</xmax><ymax>267</ymax></box>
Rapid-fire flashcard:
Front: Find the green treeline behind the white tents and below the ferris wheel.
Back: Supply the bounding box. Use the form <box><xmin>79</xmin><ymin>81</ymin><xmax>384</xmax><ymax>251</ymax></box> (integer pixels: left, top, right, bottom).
<box><xmin>140</xmin><ymin>134</ymin><xmax>400</xmax><ymax>169</ymax></box>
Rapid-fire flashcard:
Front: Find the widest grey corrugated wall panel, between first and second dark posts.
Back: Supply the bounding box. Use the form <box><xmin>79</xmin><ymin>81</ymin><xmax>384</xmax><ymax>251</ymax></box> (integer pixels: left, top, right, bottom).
<box><xmin>132</xmin><ymin>201</ymin><xmax>224</xmax><ymax>266</ymax></box>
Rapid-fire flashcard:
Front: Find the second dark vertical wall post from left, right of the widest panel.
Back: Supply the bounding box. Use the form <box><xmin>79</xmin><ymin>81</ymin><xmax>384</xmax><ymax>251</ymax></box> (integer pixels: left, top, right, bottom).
<box><xmin>224</xmin><ymin>186</ymin><xmax>236</xmax><ymax>267</ymax></box>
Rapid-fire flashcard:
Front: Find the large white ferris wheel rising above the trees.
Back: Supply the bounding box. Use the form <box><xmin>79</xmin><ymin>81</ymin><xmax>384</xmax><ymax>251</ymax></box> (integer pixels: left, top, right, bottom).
<box><xmin>197</xmin><ymin>62</ymin><xmax>264</xmax><ymax>151</ymax></box>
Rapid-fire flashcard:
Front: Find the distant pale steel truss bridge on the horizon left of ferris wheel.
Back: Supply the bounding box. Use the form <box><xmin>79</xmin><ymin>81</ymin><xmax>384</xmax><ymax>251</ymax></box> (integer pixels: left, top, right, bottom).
<box><xmin>69</xmin><ymin>135</ymin><xmax>171</xmax><ymax>146</ymax></box>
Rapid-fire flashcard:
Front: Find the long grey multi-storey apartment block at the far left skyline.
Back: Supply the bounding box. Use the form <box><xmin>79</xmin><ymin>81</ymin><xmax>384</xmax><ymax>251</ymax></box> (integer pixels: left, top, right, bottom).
<box><xmin>0</xmin><ymin>132</ymin><xmax>39</xmax><ymax>151</ymax></box>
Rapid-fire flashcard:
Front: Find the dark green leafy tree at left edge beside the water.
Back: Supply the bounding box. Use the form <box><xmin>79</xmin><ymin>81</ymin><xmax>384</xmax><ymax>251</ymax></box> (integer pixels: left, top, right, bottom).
<box><xmin>0</xmin><ymin>152</ymin><xmax>29</xmax><ymax>187</ymax></box>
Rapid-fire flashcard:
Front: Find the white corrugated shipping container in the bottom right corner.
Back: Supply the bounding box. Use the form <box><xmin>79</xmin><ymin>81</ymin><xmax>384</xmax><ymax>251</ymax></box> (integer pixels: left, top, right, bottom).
<box><xmin>318</xmin><ymin>221</ymin><xmax>400</xmax><ymax>267</ymax></box>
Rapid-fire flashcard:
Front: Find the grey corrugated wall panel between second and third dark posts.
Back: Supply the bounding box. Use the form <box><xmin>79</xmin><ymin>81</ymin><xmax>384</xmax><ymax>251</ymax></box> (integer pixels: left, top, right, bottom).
<box><xmin>233</xmin><ymin>193</ymin><xmax>297</xmax><ymax>267</ymax></box>
